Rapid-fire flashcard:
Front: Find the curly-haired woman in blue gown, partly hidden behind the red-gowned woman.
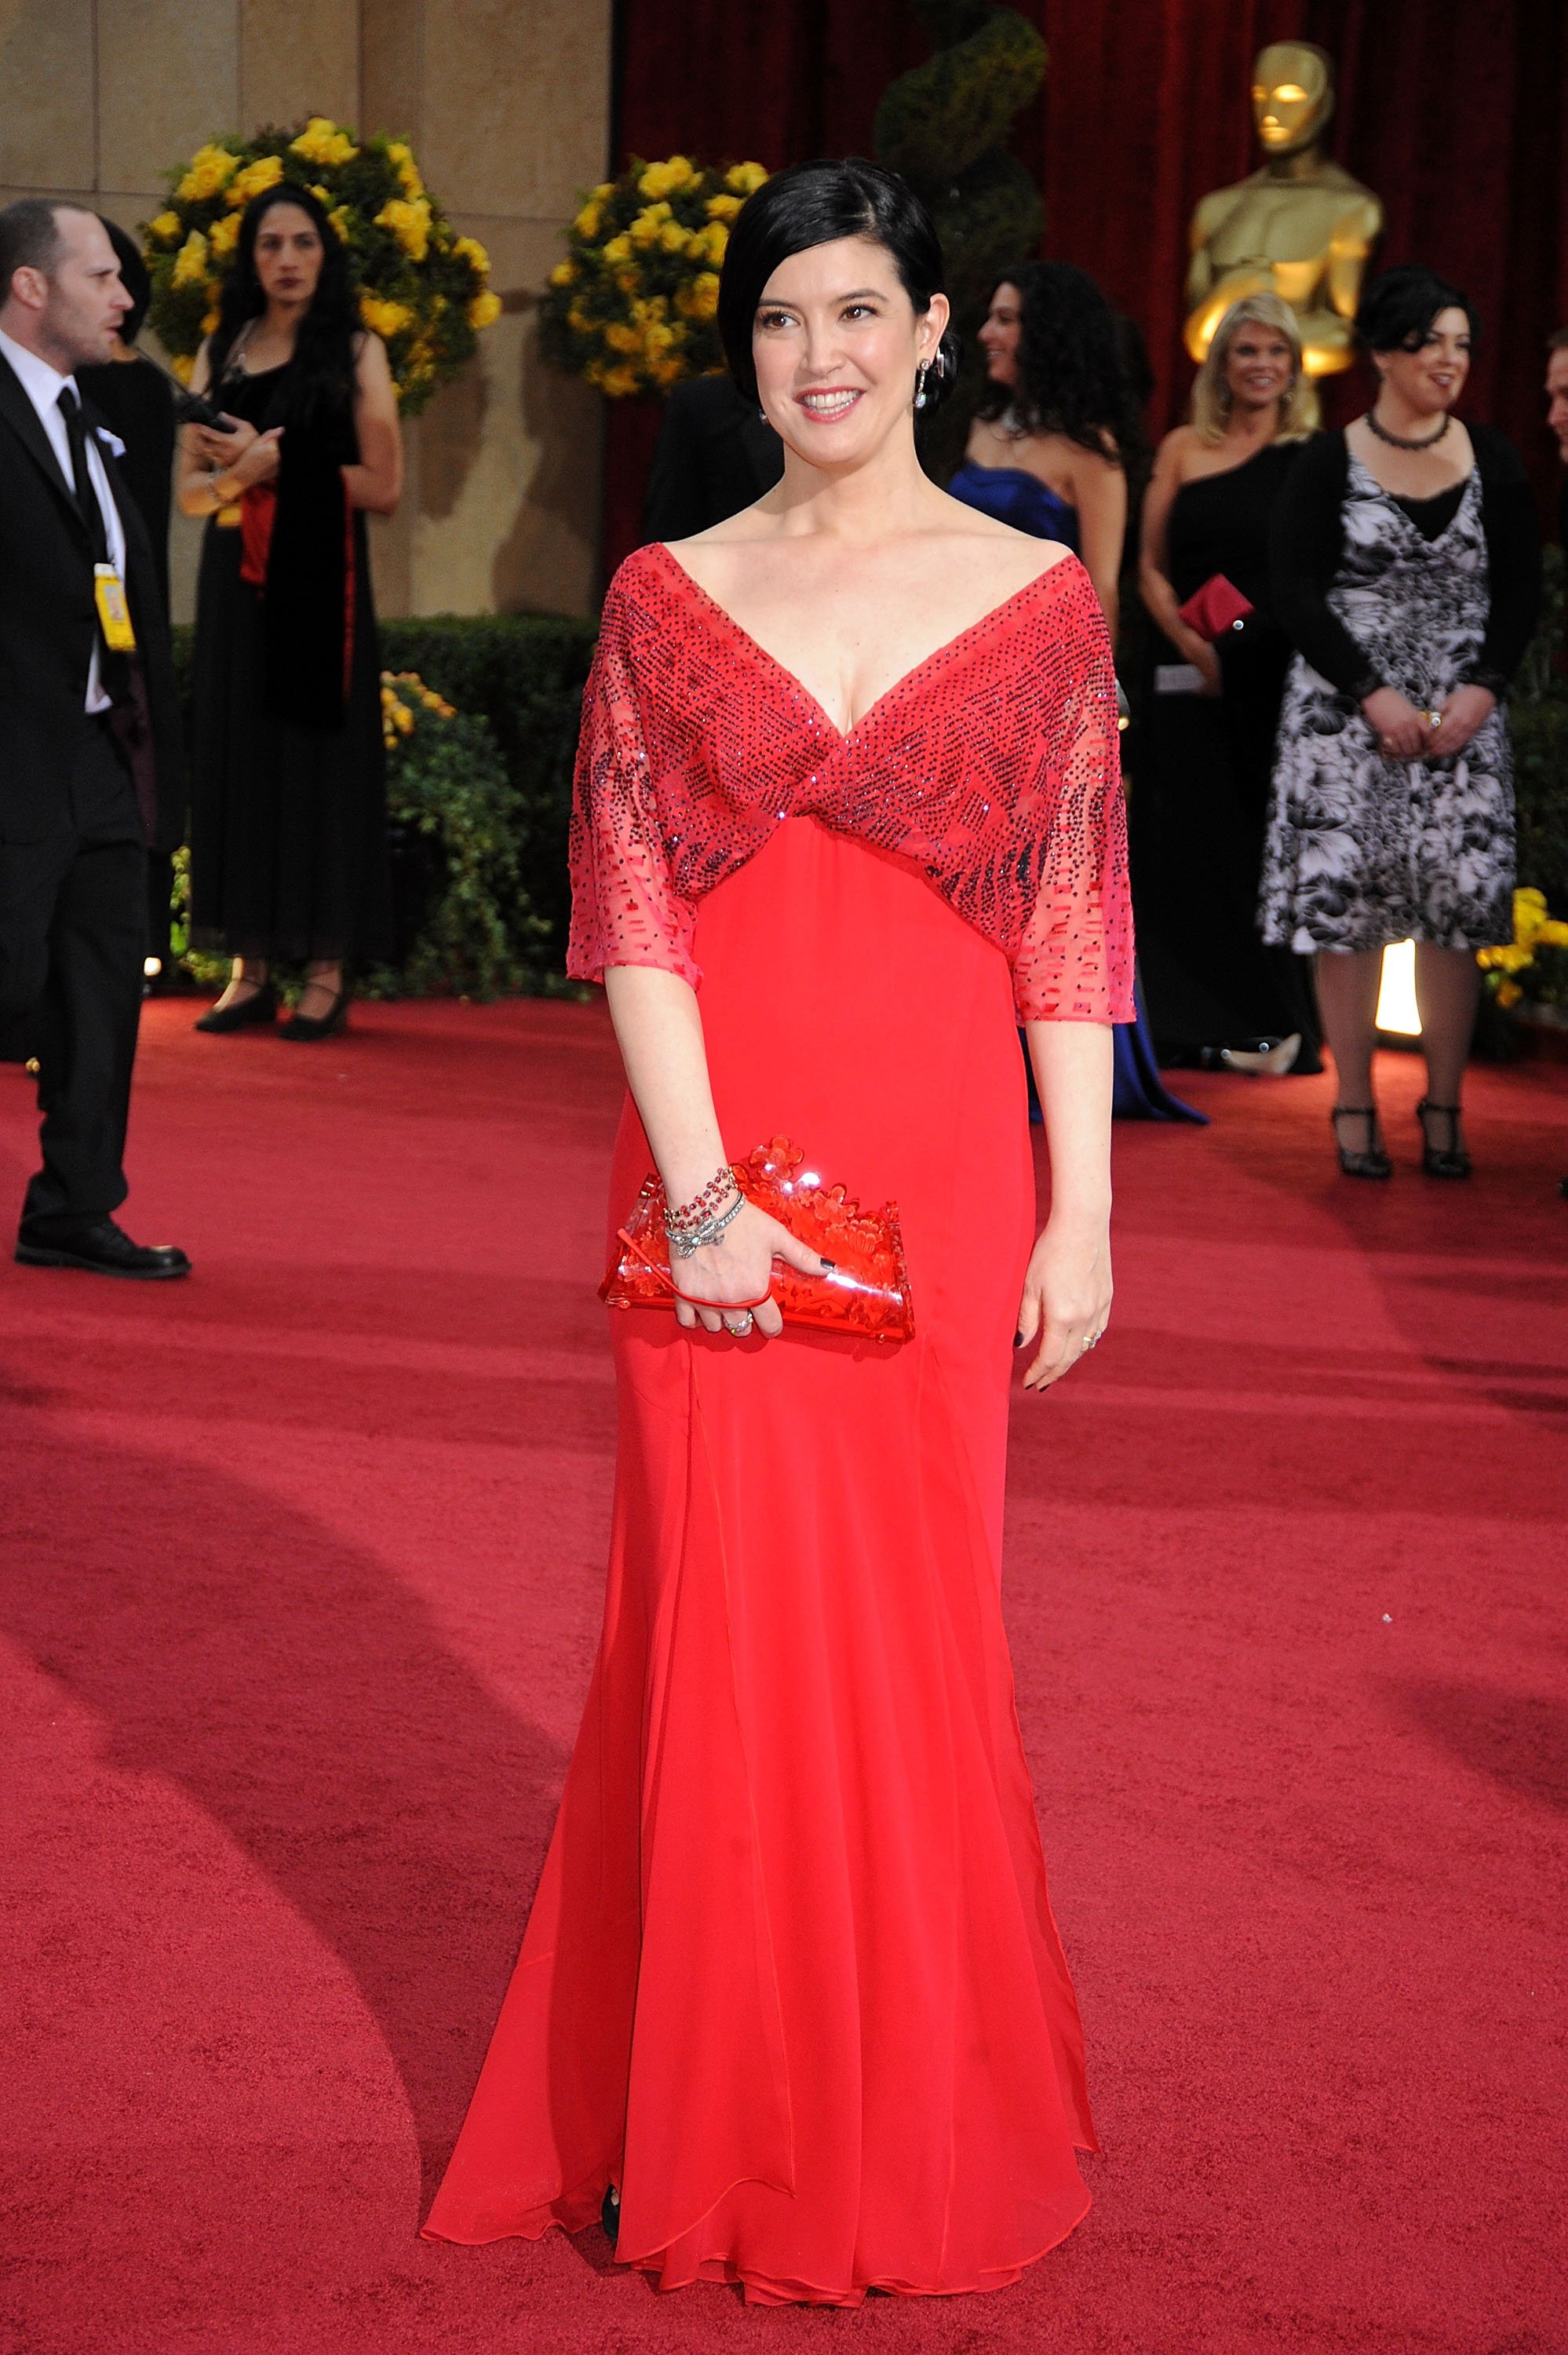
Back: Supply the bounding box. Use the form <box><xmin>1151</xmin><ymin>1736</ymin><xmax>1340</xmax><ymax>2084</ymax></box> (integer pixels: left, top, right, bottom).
<box><xmin>946</xmin><ymin>261</ymin><xmax>1203</xmax><ymax>1121</ymax></box>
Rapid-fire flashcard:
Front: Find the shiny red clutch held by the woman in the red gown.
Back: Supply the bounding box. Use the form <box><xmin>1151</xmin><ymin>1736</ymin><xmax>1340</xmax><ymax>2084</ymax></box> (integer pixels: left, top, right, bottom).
<box><xmin>598</xmin><ymin>1137</ymin><xmax>913</xmax><ymax>1342</ymax></box>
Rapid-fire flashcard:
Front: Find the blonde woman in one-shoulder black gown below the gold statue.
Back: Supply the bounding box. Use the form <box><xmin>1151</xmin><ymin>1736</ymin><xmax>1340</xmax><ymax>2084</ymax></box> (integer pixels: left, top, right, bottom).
<box><xmin>1130</xmin><ymin>294</ymin><xmax>1321</xmax><ymax>1072</ymax></box>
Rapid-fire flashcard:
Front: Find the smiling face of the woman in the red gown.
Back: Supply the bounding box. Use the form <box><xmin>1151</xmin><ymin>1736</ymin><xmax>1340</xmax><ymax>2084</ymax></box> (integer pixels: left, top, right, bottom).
<box><xmin>751</xmin><ymin>238</ymin><xmax>946</xmax><ymax>471</ymax></box>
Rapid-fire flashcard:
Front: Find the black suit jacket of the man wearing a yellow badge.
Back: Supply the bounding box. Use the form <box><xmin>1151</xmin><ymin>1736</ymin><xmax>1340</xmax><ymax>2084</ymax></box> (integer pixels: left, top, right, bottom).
<box><xmin>0</xmin><ymin>353</ymin><xmax>186</xmax><ymax>850</ymax></box>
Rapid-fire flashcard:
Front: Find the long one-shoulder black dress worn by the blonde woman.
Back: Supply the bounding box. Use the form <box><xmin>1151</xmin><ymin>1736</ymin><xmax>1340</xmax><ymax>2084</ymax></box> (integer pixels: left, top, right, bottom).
<box><xmin>1128</xmin><ymin>443</ymin><xmax>1321</xmax><ymax>1072</ymax></box>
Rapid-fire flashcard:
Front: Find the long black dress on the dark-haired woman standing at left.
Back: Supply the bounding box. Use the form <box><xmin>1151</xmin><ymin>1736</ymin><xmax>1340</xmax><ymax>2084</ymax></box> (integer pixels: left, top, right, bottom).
<box><xmin>191</xmin><ymin>365</ymin><xmax>391</xmax><ymax>963</ymax></box>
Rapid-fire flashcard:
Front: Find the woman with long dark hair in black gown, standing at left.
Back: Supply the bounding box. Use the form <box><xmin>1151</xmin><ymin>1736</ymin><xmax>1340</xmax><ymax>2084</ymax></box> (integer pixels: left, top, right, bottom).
<box><xmin>179</xmin><ymin>198</ymin><xmax>403</xmax><ymax>1039</ymax></box>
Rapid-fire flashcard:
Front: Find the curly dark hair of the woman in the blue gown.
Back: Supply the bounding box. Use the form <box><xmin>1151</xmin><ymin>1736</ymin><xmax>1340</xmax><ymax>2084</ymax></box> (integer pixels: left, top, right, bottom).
<box><xmin>977</xmin><ymin>261</ymin><xmax>1144</xmax><ymax>464</ymax></box>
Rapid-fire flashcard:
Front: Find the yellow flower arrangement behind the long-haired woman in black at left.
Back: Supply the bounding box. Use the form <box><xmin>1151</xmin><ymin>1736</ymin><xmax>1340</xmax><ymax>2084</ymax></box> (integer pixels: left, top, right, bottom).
<box><xmin>144</xmin><ymin>115</ymin><xmax>501</xmax><ymax>414</ymax></box>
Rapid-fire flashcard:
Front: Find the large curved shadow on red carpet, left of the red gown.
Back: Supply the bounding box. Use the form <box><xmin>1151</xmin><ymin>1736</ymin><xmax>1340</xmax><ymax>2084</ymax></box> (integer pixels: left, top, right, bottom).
<box><xmin>0</xmin><ymin>1411</ymin><xmax>565</xmax><ymax>2214</ymax></box>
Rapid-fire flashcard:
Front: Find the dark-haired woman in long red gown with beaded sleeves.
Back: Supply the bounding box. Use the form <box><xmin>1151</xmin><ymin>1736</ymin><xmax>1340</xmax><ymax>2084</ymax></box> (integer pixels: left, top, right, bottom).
<box><xmin>426</xmin><ymin>162</ymin><xmax>1132</xmax><ymax>2306</ymax></box>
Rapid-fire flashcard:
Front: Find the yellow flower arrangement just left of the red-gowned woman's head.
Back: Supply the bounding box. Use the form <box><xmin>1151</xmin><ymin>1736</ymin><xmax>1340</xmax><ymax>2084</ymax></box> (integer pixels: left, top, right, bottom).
<box><xmin>539</xmin><ymin>155</ymin><xmax>768</xmax><ymax>400</ymax></box>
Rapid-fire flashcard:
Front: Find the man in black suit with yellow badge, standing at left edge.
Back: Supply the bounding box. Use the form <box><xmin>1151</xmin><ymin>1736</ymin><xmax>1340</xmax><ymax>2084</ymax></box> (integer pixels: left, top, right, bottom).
<box><xmin>0</xmin><ymin>198</ymin><xmax>191</xmax><ymax>1279</ymax></box>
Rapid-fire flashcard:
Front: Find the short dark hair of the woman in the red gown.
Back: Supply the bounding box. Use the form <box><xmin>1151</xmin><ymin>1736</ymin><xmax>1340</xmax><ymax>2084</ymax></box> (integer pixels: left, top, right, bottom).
<box><xmin>718</xmin><ymin>155</ymin><xmax>958</xmax><ymax>407</ymax></box>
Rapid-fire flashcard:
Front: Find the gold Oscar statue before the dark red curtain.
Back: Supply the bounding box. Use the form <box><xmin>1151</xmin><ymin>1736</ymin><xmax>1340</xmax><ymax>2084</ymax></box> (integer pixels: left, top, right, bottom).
<box><xmin>1184</xmin><ymin>40</ymin><xmax>1382</xmax><ymax>377</ymax></box>
